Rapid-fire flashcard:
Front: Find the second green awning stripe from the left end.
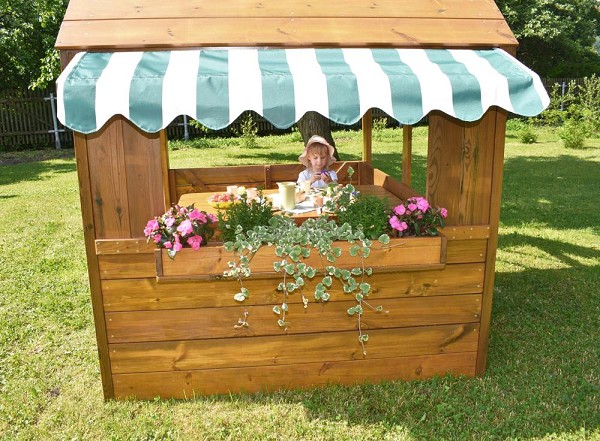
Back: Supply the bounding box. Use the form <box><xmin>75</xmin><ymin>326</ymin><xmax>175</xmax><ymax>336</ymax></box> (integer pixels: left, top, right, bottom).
<box><xmin>129</xmin><ymin>51</ymin><xmax>171</xmax><ymax>132</ymax></box>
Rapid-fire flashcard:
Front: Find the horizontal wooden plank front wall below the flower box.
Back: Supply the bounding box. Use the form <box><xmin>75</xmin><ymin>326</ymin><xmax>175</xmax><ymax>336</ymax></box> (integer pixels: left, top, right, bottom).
<box><xmin>97</xmin><ymin>226</ymin><xmax>489</xmax><ymax>398</ymax></box>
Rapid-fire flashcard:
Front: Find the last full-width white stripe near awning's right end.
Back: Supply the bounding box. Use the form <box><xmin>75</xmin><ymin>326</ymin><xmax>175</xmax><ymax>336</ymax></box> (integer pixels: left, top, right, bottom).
<box><xmin>450</xmin><ymin>49</ymin><xmax>514</xmax><ymax>112</ymax></box>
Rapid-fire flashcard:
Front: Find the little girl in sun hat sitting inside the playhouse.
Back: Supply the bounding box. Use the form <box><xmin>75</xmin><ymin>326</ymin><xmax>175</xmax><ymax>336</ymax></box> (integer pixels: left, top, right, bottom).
<box><xmin>298</xmin><ymin>135</ymin><xmax>337</xmax><ymax>188</ymax></box>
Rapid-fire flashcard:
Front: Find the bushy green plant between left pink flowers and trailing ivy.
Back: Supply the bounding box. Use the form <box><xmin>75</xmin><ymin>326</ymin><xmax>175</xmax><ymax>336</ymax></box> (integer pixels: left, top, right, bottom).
<box><xmin>218</xmin><ymin>190</ymin><xmax>273</xmax><ymax>242</ymax></box>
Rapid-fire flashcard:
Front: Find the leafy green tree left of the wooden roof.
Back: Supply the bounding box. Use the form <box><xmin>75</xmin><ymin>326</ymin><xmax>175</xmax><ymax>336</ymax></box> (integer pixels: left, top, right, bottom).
<box><xmin>0</xmin><ymin>0</ymin><xmax>69</xmax><ymax>89</ymax></box>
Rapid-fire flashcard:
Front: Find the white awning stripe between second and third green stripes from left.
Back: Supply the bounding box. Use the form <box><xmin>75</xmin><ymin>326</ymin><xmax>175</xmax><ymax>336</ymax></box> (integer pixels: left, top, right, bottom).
<box><xmin>162</xmin><ymin>50</ymin><xmax>200</xmax><ymax>124</ymax></box>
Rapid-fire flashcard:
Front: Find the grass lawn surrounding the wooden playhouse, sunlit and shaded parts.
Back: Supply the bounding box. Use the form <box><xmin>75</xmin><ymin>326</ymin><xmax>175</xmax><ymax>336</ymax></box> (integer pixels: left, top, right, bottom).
<box><xmin>0</xmin><ymin>128</ymin><xmax>600</xmax><ymax>441</ymax></box>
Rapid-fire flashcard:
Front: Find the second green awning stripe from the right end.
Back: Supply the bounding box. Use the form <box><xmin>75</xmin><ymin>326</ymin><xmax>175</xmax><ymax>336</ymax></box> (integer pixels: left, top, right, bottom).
<box><xmin>425</xmin><ymin>49</ymin><xmax>483</xmax><ymax>121</ymax></box>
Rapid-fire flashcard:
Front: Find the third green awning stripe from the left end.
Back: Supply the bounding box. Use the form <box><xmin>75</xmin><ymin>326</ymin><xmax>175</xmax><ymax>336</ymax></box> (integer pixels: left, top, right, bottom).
<box><xmin>196</xmin><ymin>50</ymin><xmax>229</xmax><ymax>130</ymax></box>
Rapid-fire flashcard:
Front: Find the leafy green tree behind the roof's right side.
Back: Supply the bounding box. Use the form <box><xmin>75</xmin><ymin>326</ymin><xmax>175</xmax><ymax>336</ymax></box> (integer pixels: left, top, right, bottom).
<box><xmin>497</xmin><ymin>0</ymin><xmax>600</xmax><ymax>78</ymax></box>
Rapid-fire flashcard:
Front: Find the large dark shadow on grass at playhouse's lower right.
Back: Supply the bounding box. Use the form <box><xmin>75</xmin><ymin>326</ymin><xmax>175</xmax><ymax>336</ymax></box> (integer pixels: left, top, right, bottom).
<box><xmin>197</xmin><ymin>258</ymin><xmax>600</xmax><ymax>440</ymax></box>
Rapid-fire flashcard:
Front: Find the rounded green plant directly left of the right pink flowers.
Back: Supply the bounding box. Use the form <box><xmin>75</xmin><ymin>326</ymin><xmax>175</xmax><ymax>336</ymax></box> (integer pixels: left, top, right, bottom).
<box><xmin>336</xmin><ymin>194</ymin><xmax>389</xmax><ymax>239</ymax></box>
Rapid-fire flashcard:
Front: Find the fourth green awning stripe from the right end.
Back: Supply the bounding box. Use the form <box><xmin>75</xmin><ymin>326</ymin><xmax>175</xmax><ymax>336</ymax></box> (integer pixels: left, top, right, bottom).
<box><xmin>315</xmin><ymin>49</ymin><xmax>361</xmax><ymax>124</ymax></box>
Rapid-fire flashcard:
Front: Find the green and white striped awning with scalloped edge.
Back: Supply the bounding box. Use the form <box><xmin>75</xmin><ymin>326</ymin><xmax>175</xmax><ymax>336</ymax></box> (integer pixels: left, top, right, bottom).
<box><xmin>57</xmin><ymin>48</ymin><xmax>550</xmax><ymax>133</ymax></box>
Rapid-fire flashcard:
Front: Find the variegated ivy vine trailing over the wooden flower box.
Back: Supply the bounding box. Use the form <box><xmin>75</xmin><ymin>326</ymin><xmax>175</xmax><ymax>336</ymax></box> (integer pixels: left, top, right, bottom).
<box><xmin>224</xmin><ymin>216</ymin><xmax>390</xmax><ymax>355</ymax></box>
